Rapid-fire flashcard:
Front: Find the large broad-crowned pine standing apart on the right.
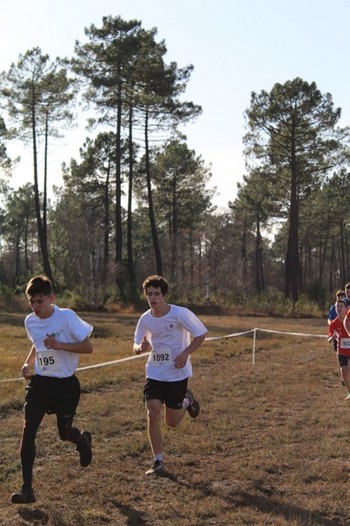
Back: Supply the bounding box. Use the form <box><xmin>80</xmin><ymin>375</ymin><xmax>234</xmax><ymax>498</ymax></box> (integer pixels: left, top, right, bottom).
<box><xmin>244</xmin><ymin>78</ymin><xmax>349</xmax><ymax>303</ymax></box>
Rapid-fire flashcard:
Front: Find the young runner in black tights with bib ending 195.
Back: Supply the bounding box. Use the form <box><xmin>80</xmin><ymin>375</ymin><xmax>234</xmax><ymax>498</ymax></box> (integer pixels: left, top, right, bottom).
<box><xmin>11</xmin><ymin>276</ymin><xmax>93</xmax><ymax>504</ymax></box>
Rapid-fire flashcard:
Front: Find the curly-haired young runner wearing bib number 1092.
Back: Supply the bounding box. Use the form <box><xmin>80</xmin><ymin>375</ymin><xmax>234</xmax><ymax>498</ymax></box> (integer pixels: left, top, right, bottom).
<box><xmin>134</xmin><ymin>275</ymin><xmax>207</xmax><ymax>475</ymax></box>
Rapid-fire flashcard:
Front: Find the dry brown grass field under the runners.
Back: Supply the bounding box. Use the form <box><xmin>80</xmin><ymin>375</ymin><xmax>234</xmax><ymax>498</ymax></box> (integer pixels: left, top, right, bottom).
<box><xmin>0</xmin><ymin>313</ymin><xmax>350</xmax><ymax>526</ymax></box>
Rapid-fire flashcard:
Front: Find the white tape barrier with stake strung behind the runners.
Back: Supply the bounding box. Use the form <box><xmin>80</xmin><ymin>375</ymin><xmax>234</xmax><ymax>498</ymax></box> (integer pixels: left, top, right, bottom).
<box><xmin>0</xmin><ymin>327</ymin><xmax>328</xmax><ymax>384</ymax></box>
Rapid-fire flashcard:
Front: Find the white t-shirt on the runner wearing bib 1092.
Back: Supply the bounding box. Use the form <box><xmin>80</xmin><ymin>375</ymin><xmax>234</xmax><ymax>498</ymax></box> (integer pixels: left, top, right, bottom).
<box><xmin>134</xmin><ymin>305</ymin><xmax>207</xmax><ymax>382</ymax></box>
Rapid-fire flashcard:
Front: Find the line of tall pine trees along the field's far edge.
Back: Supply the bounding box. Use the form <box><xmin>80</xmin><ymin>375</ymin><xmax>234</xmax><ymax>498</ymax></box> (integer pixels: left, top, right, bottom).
<box><xmin>0</xmin><ymin>16</ymin><xmax>350</xmax><ymax>308</ymax></box>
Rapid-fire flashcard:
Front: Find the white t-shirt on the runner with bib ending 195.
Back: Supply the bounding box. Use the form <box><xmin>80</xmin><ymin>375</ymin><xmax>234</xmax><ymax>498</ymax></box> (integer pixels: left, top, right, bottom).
<box><xmin>24</xmin><ymin>305</ymin><xmax>93</xmax><ymax>378</ymax></box>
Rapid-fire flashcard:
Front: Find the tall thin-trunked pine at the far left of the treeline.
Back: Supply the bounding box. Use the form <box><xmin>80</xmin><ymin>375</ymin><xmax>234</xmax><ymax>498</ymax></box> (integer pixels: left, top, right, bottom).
<box><xmin>0</xmin><ymin>47</ymin><xmax>75</xmax><ymax>279</ymax></box>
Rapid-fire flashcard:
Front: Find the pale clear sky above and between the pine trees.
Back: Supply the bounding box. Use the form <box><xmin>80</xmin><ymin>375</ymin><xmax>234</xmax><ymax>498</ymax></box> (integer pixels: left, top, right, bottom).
<box><xmin>0</xmin><ymin>0</ymin><xmax>350</xmax><ymax>207</ymax></box>
